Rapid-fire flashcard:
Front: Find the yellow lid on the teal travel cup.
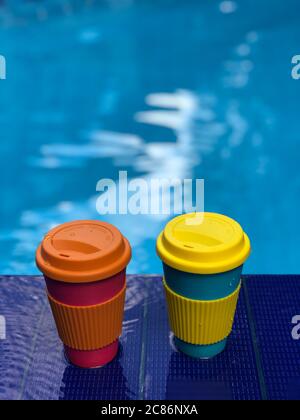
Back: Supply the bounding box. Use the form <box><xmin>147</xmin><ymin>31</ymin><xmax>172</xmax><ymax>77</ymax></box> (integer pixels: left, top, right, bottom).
<box><xmin>156</xmin><ymin>213</ymin><xmax>251</xmax><ymax>274</ymax></box>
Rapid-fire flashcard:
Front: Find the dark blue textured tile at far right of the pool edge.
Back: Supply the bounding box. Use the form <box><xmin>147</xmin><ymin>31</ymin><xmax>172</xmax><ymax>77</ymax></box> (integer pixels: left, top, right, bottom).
<box><xmin>247</xmin><ymin>275</ymin><xmax>300</xmax><ymax>400</ymax></box>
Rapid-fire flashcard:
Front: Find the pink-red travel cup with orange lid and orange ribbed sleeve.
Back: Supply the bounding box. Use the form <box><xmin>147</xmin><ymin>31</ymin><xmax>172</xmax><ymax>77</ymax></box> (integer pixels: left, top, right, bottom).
<box><xmin>36</xmin><ymin>220</ymin><xmax>131</xmax><ymax>368</ymax></box>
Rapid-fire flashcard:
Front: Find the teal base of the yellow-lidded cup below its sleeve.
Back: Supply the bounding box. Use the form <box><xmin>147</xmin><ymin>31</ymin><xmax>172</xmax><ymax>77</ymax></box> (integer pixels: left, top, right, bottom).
<box><xmin>174</xmin><ymin>337</ymin><xmax>227</xmax><ymax>359</ymax></box>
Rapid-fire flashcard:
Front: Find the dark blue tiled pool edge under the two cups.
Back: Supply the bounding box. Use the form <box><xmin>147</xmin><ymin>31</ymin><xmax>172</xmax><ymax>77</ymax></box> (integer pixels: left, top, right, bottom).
<box><xmin>0</xmin><ymin>275</ymin><xmax>300</xmax><ymax>400</ymax></box>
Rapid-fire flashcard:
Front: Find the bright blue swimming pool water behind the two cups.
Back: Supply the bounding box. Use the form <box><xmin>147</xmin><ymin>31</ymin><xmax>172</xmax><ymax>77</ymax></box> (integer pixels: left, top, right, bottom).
<box><xmin>0</xmin><ymin>0</ymin><xmax>300</xmax><ymax>274</ymax></box>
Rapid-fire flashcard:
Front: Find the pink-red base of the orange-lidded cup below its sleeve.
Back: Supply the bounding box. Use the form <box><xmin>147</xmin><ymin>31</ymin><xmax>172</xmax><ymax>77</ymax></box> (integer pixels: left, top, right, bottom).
<box><xmin>65</xmin><ymin>340</ymin><xmax>119</xmax><ymax>369</ymax></box>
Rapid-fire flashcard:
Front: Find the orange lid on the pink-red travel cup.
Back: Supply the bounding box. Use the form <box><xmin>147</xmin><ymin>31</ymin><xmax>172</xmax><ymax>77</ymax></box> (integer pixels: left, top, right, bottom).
<box><xmin>36</xmin><ymin>220</ymin><xmax>131</xmax><ymax>283</ymax></box>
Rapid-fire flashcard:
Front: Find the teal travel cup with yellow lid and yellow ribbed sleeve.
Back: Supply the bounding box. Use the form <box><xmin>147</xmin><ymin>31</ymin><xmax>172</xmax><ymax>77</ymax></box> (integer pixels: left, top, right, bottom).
<box><xmin>157</xmin><ymin>213</ymin><xmax>250</xmax><ymax>358</ymax></box>
